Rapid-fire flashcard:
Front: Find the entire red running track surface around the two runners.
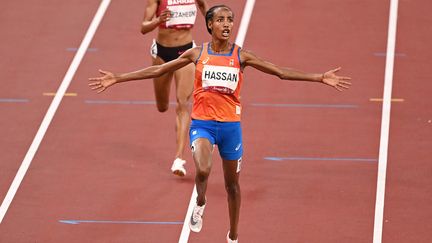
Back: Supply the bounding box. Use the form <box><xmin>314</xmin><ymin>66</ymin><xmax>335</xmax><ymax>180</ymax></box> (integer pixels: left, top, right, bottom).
<box><xmin>0</xmin><ymin>0</ymin><xmax>432</xmax><ymax>243</ymax></box>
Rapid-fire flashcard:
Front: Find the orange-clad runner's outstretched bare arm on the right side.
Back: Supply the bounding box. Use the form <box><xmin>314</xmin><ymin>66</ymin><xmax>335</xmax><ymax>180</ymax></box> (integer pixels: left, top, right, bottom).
<box><xmin>240</xmin><ymin>50</ymin><xmax>351</xmax><ymax>91</ymax></box>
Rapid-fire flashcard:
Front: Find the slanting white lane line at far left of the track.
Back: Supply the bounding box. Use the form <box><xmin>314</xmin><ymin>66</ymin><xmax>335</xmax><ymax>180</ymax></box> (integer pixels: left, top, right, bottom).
<box><xmin>0</xmin><ymin>0</ymin><xmax>111</xmax><ymax>224</ymax></box>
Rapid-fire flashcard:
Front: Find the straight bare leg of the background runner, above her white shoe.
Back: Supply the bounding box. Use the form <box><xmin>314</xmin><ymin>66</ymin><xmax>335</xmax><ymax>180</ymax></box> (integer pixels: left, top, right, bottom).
<box><xmin>174</xmin><ymin>64</ymin><xmax>195</xmax><ymax>158</ymax></box>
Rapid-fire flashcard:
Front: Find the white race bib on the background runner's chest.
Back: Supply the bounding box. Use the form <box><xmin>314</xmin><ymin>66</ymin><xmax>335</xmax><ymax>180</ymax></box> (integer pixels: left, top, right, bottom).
<box><xmin>166</xmin><ymin>4</ymin><xmax>197</xmax><ymax>27</ymax></box>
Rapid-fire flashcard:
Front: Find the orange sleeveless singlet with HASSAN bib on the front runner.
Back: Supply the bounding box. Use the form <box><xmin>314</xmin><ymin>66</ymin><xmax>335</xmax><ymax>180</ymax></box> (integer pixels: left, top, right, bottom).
<box><xmin>191</xmin><ymin>43</ymin><xmax>243</xmax><ymax>122</ymax></box>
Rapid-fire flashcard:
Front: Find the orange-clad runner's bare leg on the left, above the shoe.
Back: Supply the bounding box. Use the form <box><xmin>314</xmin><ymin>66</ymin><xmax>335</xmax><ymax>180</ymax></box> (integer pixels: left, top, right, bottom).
<box><xmin>192</xmin><ymin>138</ymin><xmax>213</xmax><ymax>206</ymax></box>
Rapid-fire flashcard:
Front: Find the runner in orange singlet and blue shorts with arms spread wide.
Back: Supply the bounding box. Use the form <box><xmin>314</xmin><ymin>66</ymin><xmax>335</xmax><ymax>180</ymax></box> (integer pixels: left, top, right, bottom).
<box><xmin>89</xmin><ymin>5</ymin><xmax>351</xmax><ymax>243</ymax></box>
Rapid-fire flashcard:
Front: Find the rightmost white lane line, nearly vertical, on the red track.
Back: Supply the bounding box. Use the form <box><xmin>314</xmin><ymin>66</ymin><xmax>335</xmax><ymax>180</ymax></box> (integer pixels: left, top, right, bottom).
<box><xmin>373</xmin><ymin>0</ymin><xmax>398</xmax><ymax>243</ymax></box>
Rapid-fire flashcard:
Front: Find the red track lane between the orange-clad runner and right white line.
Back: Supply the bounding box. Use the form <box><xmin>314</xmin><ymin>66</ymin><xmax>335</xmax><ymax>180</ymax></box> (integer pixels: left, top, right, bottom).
<box><xmin>233</xmin><ymin>1</ymin><xmax>388</xmax><ymax>242</ymax></box>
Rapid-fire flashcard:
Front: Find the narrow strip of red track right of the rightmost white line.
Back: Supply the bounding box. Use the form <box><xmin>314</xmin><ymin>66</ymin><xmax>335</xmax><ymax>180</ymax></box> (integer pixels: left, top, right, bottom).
<box><xmin>383</xmin><ymin>0</ymin><xmax>432</xmax><ymax>243</ymax></box>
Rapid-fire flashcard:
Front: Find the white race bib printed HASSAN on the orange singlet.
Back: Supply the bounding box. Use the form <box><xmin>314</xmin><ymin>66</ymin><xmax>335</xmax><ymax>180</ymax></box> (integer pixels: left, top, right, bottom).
<box><xmin>201</xmin><ymin>65</ymin><xmax>240</xmax><ymax>94</ymax></box>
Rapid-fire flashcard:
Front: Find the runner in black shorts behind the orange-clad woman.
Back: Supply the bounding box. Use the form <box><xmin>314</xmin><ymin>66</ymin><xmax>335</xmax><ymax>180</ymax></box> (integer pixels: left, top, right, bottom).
<box><xmin>141</xmin><ymin>0</ymin><xmax>208</xmax><ymax>176</ymax></box>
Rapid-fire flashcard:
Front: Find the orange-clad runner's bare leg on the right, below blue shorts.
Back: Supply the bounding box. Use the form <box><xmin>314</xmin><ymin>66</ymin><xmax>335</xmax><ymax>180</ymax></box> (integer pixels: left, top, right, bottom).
<box><xmin>223</xmin><ymin>159</ymin><xmax>241</xmax><ymax>240</ymax></box>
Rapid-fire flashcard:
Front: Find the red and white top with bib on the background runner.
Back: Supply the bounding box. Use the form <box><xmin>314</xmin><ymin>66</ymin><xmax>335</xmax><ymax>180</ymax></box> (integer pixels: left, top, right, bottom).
<box><xmin>156</xmin><ymin>0</ymin><xmax>197</xmax><ymax>29</ymax></box>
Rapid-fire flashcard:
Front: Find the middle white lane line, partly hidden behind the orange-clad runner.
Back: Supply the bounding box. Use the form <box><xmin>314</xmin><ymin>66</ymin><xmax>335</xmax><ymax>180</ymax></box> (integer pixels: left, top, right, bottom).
<box><xmin>178</xmin><ymin>0</ymin><xmax>255</xmax><ymax>243</ymax></box>
